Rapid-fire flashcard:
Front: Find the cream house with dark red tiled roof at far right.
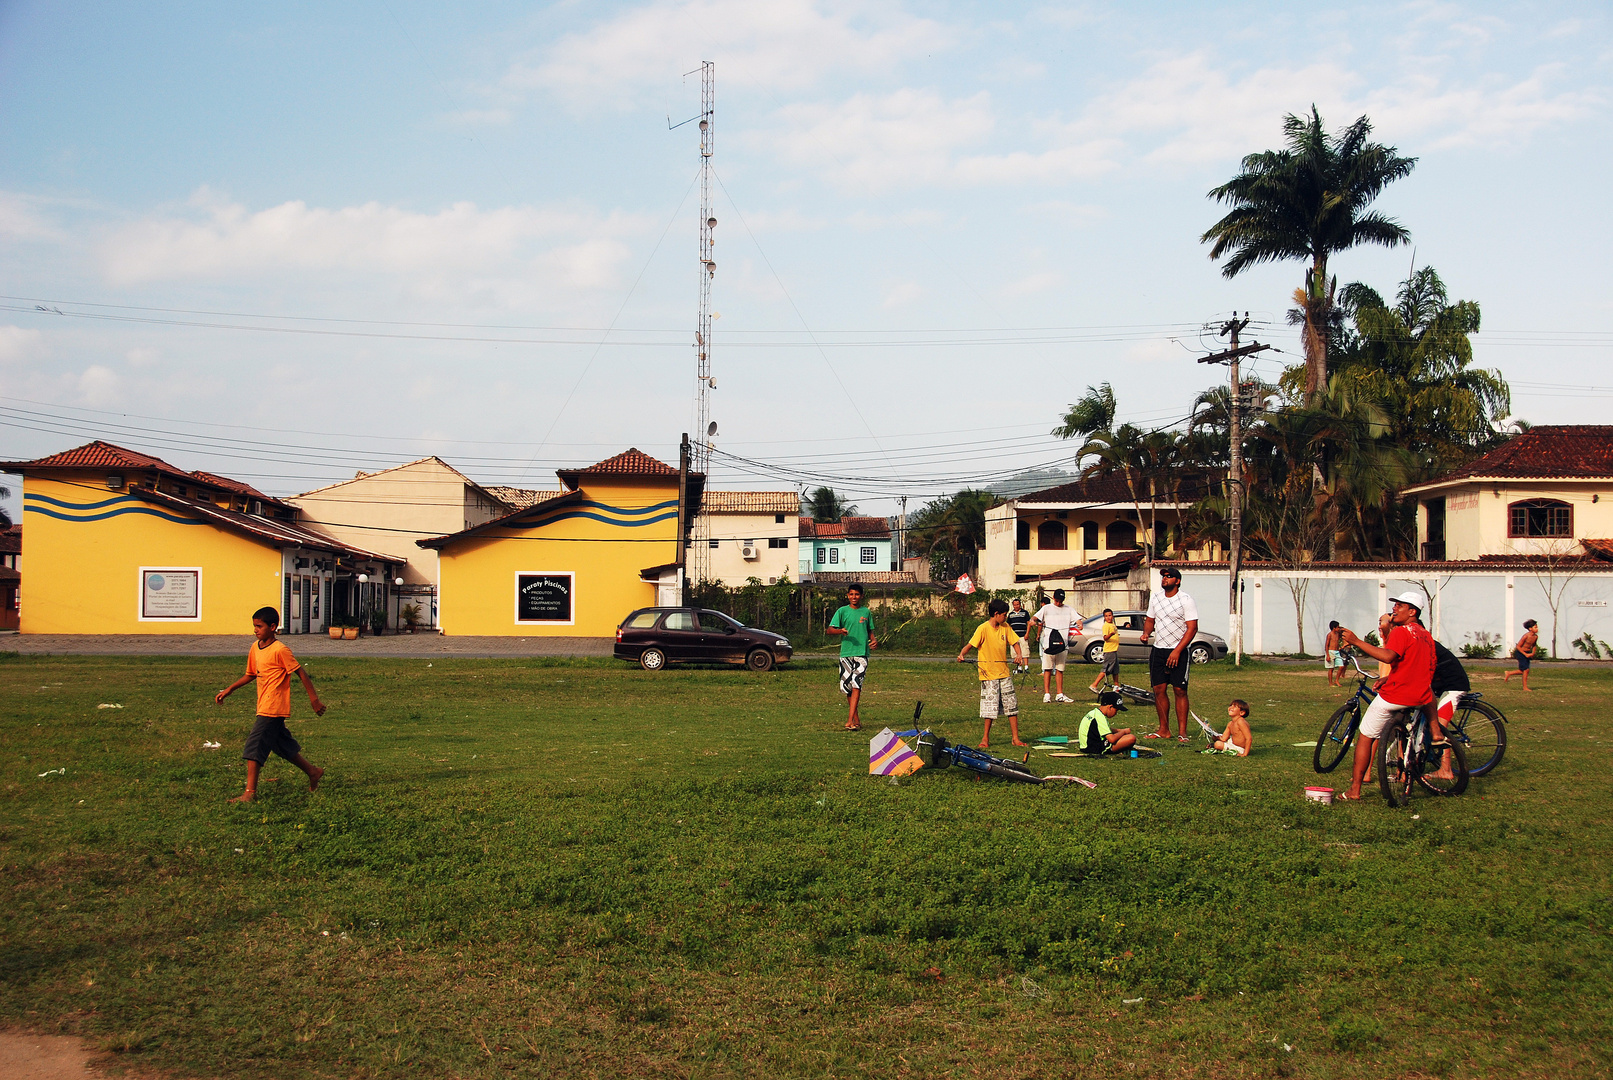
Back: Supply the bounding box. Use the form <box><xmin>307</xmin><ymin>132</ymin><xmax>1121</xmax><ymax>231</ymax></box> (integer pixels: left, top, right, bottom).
<box><xmin>1405</xmin><ymin>424</ymin><xmax>1613</xmax><ymax>561</ymax></box>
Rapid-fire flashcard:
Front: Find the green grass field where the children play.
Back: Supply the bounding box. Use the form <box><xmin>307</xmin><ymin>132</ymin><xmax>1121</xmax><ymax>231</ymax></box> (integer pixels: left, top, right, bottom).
<box><xmin>0</xmin><ymin>642</ymin><xmax>1613</xmax><ymax>1078</ymax></box>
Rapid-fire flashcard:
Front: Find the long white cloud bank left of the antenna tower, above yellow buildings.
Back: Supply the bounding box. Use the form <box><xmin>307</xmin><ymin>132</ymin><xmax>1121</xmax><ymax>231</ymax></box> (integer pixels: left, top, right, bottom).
<box><xmin>100</xmin><ymin>190</ymin><xmax>648</xmax><ymax>303</ymax></box>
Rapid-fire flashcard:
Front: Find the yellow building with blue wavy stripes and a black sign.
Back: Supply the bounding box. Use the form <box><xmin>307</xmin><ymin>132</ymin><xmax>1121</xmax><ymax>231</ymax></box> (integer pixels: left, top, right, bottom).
<box><xmin>418</xmin><ymin>450</ymin><xmax>705</xmax><ymax>637</ymax></box>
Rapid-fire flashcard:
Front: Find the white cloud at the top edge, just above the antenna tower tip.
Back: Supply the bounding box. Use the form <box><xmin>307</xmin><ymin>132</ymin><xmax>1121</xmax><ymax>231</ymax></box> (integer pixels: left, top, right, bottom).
<box><xmin>505</xmin><ymin>0</ymin><xmax>955</xmax><ymax>107</ymax></box>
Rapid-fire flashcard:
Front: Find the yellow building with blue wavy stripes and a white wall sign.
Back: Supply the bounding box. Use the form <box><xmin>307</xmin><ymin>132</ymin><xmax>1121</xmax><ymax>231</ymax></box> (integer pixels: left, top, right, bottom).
<box><xmin>0</xmin><ymin>442</ymin><xmax>402</xmax><ymax>635</ymax></box>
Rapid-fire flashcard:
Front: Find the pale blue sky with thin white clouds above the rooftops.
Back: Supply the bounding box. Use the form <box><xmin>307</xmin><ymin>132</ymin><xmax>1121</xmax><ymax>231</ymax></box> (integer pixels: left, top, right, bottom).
<box><xmin>0</xmin><ymin>0</ymin><xmax>1613</xmax><ymax>525</ymax></box>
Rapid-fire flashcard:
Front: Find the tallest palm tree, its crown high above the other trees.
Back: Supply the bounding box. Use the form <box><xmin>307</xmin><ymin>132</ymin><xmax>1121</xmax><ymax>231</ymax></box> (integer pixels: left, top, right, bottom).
<box><xmin>1200</xmin><ymin>105</ymin><xmax>1416</xmax><ymax>398</ymax></box>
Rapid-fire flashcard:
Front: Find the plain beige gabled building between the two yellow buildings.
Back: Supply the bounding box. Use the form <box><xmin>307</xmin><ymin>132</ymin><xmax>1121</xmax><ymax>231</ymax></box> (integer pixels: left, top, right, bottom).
<box><xmin>286</xmin><ymin>458</ymin><xmax>511</xmax><ymax>625</ymax></box>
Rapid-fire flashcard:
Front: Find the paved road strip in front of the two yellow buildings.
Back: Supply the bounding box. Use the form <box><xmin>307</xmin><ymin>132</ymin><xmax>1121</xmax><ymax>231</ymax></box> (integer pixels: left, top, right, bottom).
<box><xmin>0</xmin><ymin>633</ymin><xmax>616</xmax><ymax>659</ymax></box>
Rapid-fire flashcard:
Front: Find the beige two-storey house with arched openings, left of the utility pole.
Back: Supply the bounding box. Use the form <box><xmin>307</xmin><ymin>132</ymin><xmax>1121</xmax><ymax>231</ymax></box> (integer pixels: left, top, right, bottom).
<box><xmin>979</xmin><ymin>477</ymin><xmax>1224</xmax><ymax>588</ymax></box>
